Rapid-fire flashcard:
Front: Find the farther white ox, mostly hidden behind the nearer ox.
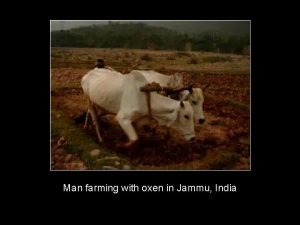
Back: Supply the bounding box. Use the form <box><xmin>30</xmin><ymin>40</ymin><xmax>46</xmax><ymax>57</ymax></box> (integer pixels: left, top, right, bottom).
<box><xmin>133</xmin><ymin>70</ymin><xmax>205</xmax><ymax>124</ymax></box>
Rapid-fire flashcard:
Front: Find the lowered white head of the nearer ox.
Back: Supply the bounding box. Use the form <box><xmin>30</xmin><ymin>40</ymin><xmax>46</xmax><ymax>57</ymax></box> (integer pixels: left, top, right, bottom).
<box><xmin>172</xmin><ymin>101</ymin><xmax>195</xmax><ymax>141</ymax></box>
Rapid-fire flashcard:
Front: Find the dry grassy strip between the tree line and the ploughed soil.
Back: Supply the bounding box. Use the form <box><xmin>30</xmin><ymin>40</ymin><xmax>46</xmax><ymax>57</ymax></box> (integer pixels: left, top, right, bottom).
<box><xmin>51</xmin><ymin>48</ymin><xmax>250</xmax><ymax>75</ymax></box>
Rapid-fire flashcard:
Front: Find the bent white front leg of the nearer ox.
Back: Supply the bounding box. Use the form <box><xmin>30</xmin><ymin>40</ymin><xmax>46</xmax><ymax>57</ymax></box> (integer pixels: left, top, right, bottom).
<box><xmin>116</xmin><ymin>114</ymin><xmax>138</xmax><ymax>148</ymax></box>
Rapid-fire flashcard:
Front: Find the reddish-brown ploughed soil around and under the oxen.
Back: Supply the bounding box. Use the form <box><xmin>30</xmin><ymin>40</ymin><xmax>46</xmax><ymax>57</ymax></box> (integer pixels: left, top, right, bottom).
<box><xmin>52</xmin><ymin>69</ymin><xmax>250</xmax><ymax>169</ymax></box>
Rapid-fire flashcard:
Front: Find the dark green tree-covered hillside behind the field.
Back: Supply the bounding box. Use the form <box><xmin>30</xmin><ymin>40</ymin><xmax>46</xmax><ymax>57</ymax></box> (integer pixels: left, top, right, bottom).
<box><xmin>51</xmin><ymin>22</ymin><xmax>250</xmax><ymax>54</ymax></box>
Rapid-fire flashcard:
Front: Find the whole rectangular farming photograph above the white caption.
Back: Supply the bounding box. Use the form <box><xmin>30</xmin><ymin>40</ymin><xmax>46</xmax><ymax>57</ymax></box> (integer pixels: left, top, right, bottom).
<box><xmin>49</xmin><ymin>20</ymin><xmax>251</xmax><ymax>172</ymax></box>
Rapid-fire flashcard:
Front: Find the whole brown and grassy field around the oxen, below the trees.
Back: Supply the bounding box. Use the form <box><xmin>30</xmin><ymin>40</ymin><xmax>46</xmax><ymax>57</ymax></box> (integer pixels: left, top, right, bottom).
<box><xmin>51</xmin><ymin>48</ymin><xmax>250</xmax><ymax>170</ymax></box>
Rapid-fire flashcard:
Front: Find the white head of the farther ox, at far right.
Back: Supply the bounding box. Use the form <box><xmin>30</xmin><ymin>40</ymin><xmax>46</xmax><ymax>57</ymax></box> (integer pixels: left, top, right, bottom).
<box><xmin>180</xmin><ymin>85</ymin><xmax>209</xmax><ymax>124</ymax></box>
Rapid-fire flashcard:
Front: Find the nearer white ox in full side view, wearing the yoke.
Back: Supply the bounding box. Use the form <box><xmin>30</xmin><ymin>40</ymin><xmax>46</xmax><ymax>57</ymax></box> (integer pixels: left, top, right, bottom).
<box><xmin>81</xmin><ymin>69</ymin><xmax>195</xmax><ymax>147</ymax></box>
